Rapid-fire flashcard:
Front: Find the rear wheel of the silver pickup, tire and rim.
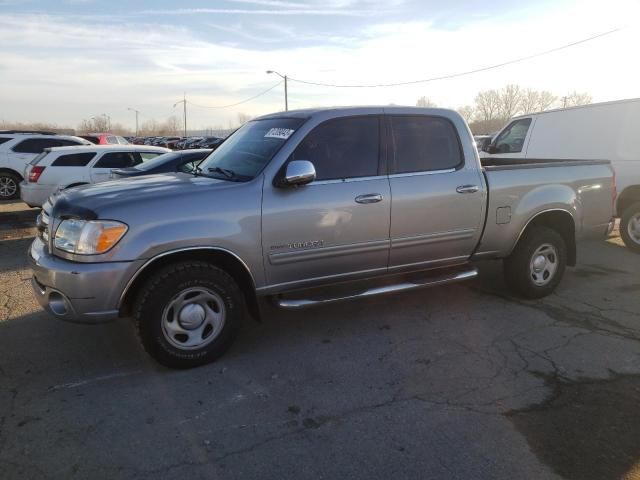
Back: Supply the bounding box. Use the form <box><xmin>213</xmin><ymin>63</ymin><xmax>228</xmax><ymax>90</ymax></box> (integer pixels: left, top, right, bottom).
<box><xmin>504</xmin><ymin>227</ymin><xmax>567</xmax><ymax>299</ymax></box>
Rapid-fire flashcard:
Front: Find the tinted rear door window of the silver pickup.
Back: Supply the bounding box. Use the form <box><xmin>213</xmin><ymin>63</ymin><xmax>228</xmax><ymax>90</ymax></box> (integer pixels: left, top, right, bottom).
<box><xmin>390</xmin><ymin>116</ymin><xmax>463</xmax><ymax>173</ymax></box>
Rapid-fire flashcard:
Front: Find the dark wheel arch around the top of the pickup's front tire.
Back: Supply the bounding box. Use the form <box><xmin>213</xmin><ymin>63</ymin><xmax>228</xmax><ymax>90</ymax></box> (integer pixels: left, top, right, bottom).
<box><xmin>118</xmin><ymin>247</ymin><xmax>260</xmax><ymax>321</ymax></box>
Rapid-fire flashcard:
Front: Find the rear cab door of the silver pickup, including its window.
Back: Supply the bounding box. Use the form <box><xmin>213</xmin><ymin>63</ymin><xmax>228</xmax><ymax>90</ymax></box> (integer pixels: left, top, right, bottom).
<box><xmin>387</xmin><ymin>115</ymin><xmax>485</xmax><ymax>270</ymax></box>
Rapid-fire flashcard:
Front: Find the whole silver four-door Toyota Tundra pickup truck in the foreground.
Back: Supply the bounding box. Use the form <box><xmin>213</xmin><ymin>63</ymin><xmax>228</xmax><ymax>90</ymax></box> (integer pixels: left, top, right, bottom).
<box><xmin>29</xmin><ymin>107</ymin><xmax>614</xmax><ymax>368</ymax></box>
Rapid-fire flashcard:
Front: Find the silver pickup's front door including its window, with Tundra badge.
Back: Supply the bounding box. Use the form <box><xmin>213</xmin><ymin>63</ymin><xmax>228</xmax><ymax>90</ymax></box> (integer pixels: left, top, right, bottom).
<box><xmin>262</xmin><ymin>115</ymin><xmax>391</xmax><ymax>286</ymax></box>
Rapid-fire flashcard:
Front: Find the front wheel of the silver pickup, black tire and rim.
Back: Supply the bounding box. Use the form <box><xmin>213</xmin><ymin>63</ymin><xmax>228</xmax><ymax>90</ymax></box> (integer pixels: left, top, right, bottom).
<box><xmin>134</xmin><ymin>261</ymin><xmax>245</xmax><ymax>369</ymax></box>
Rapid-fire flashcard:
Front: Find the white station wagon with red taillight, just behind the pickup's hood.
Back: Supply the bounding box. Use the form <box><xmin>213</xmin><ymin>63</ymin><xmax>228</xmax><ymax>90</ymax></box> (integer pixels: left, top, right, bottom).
<box><xmin>20</xmin><ymin>145</ymin><xmax>171</xmax><ymax>207</ymax></box>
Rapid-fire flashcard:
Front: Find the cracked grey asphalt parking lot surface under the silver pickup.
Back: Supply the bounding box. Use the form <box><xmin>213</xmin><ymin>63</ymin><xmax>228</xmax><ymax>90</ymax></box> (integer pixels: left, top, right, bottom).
<box><xmin>0</xmin><ymin>202</ymin><xmax>640</xmax><ymax>479</ymax></box>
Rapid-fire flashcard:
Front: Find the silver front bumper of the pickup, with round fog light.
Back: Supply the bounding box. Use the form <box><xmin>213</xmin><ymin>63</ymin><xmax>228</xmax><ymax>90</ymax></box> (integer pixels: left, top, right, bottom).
<box><xmin>28</xmin><ymin>238</ymin><xmax>137</xmax><ymax>323</ymax></box>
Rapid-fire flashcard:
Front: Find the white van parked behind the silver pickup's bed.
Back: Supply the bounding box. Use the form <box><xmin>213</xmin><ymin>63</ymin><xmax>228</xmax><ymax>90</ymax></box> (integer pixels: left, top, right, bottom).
<box><xmin>480</xmin><ymin>98</ymin><xmax>640</xmax><ymax>252</ymax></box>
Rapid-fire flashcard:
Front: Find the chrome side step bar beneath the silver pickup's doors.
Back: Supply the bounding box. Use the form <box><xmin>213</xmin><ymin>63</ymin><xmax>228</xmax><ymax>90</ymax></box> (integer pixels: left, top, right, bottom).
<box><xmin>273</xmin><ymin>267</ymin><xmax>478</xmax><ymax>310</ymax></box>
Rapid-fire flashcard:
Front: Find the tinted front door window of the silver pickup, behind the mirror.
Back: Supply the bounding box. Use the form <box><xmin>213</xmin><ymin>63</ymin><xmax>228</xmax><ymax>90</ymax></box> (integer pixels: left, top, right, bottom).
<box><xmin>291</xmin><ymin>116</ymin><xmax>380</xmax><ymax>180</ymax></box>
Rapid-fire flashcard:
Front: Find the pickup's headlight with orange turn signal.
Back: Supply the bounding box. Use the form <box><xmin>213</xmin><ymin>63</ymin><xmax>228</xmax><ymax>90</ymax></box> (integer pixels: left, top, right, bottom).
<box><xmin>54</xmin><ymin>219</ymin><xmax>128</xmax><ymax>255</ymax></box>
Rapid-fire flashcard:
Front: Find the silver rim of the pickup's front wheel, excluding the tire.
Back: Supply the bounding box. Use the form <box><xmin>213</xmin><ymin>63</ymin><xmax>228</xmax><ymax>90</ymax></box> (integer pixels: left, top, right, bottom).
<box><xmin>162</xmin><ymin>287</ymin><xmax>226</xmax><ymax>350</ymax></box>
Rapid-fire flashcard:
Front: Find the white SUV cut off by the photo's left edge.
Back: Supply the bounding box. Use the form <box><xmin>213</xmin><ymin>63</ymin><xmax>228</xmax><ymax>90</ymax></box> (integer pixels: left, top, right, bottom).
<box><xmin>0</xmin><ymin>130</ymin><xmax>91</xmax><ymax>200</ymax></box>
